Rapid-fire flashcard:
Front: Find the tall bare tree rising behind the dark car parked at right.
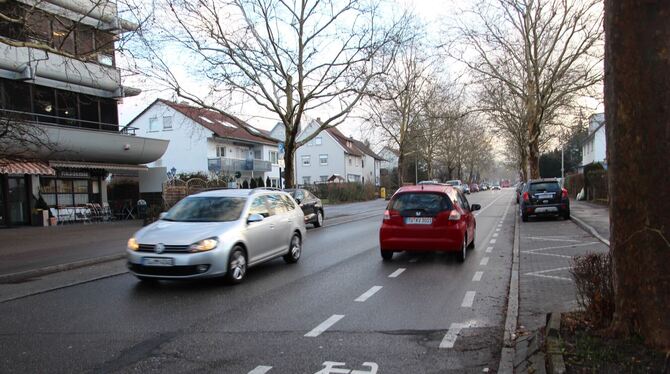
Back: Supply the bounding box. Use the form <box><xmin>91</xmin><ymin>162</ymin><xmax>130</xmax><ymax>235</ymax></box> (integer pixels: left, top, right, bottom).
<box><xmin>449</xmin><ymin>0</ymin><xmax>603</xmax><ymax>178</ymax></box>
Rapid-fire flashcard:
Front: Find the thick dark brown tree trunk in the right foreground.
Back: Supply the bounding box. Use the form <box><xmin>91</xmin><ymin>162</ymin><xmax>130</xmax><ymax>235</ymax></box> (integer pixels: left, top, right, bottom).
<box><xmin>605</xmin><ymin>0</ymin><xmax>670</xmax><ymax>351</ymax></box>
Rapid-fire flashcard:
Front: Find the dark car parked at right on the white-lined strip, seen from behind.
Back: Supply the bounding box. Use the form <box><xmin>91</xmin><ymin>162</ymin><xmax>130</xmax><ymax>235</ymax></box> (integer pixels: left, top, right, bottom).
<box><xmin>519</xmin><ymin>178</ymin><xmax>570</xmax><ymax>222</ymax></box>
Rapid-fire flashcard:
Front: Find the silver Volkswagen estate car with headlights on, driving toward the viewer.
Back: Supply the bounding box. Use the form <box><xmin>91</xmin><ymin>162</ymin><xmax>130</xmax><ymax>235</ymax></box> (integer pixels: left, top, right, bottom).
<box><xmin>127</xmin><ymin>189</ymin><xmax>306</xmax><ymax>283</ymax></box>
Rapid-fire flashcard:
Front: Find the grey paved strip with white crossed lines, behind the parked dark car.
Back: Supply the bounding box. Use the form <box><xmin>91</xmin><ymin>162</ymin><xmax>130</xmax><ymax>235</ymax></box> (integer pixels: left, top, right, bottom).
<box><xmin>515</xmin><ymin>215</ymin><xmax>608</xmax><ymax>373</ymax></box>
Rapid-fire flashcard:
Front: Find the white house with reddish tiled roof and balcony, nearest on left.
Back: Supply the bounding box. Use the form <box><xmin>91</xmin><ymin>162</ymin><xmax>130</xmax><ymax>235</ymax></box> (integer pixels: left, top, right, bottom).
<box><xmin>128</xmin><ymin>99</ymin><xmax>279</xmax><ymax>187</ymax></box>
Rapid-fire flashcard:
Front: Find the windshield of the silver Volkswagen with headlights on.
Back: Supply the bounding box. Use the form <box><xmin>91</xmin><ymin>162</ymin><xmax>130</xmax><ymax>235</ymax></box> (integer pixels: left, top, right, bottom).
<box><xmin>163</xmin><ymin>196</ymin><xmax>246</xmax><ymax>222</ymax></box>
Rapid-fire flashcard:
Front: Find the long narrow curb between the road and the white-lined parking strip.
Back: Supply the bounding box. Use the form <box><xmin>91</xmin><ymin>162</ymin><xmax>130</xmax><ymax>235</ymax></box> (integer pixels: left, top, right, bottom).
<box><xmin>498</xmin><ymin>205</ymin><xmax>520</xmax><ymax>374</ymax></box>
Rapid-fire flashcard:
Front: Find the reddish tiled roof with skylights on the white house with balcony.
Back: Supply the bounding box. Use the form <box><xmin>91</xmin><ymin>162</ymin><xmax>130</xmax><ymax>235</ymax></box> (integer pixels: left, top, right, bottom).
<box><xmin>157</xmin><ymin>99</ymin><xmax>278</xmax><ymax>145</ymax></box>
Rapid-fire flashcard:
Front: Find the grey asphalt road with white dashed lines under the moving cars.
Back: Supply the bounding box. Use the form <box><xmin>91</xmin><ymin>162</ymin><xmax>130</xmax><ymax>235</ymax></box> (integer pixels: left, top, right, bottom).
<box><xmin>0</xmin><ymin>190</ymin><xmax>514</xmax><ymax>374</ymax></box>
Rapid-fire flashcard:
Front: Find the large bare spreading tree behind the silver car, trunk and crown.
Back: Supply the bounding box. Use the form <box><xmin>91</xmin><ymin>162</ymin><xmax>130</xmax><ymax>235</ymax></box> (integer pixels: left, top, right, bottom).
<box><xmin>124</xmin><ymin>0</ymin><xmax>408</xmax><ymax>186</ymax></box>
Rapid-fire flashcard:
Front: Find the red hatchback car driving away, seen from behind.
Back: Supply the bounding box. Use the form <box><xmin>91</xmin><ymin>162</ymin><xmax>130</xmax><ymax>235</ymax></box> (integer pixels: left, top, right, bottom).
<box><xmin>379</xmin><ymin>184</ymin><xmax>481</xmax><ymax>261</ymax></box>
